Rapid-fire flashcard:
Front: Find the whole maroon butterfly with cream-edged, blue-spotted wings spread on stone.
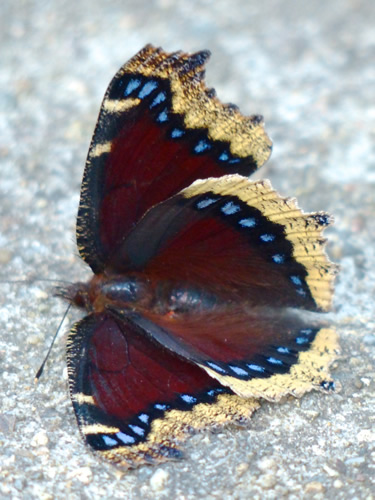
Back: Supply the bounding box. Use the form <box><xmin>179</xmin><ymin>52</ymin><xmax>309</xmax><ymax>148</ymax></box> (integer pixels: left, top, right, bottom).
<box><xmin>62</xmin><ymin>45</ymin><xmax>337</xmax><ymax>467</ymax></box>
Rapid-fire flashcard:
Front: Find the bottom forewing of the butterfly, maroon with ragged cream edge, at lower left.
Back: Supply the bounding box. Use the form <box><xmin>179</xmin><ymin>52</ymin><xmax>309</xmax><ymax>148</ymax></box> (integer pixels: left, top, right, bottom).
<box><xmin>67</xmin><ymin>313</ymin><xmax>258</xmax><ymax>467</ymax></box>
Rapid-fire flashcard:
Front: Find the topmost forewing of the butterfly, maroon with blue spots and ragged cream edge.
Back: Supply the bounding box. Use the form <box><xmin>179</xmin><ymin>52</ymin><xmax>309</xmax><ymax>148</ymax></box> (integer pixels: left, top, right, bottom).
<box><xmin>77</xmin><ymin>45</ymin><xmax>271</xmax><ymax>273</ymax></box>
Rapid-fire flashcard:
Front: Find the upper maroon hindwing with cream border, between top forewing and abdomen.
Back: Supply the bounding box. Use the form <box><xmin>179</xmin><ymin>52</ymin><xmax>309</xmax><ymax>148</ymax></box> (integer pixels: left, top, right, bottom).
<box><xmin>109</xmin><ymin>175</ymin><xmax>336</xmax><ymax>311</ymax></box>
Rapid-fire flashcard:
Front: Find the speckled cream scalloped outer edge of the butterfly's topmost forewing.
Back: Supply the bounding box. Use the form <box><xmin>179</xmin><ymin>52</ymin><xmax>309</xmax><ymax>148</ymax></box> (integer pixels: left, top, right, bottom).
<box><xmin>107</xmin><ymin>44</ymin><xmax>272</xmax><ymax>167</ymax></box>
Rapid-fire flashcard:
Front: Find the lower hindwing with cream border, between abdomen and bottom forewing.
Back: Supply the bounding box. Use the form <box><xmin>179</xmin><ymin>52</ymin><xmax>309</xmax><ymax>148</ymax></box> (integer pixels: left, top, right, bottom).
<box><xmin>128</xmin><ymin>306</ymin><xmax>338</xmax><ymax>401</ymax></box>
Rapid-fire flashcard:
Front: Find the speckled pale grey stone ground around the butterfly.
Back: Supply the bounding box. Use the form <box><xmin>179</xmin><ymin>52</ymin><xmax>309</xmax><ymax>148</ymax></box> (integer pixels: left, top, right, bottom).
<box><xmin>0</xmin><ymin>0</ymin><xmax>375</xmax><ymax>500</ymax></box>
